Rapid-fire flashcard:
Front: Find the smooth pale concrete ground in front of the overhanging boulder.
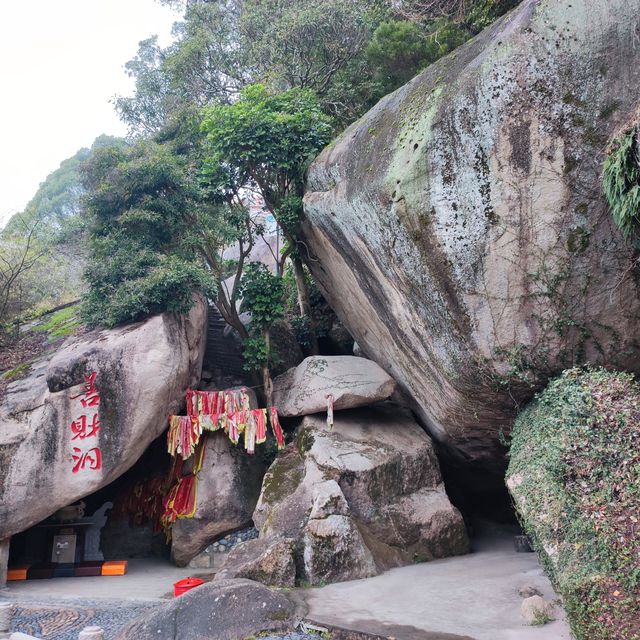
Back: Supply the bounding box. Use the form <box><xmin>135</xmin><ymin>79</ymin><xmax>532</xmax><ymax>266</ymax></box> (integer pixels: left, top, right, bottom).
<box><xmin>303</xmin><ymin>535</ymin><xmax>571</xmax><ymax>640</ymax></box>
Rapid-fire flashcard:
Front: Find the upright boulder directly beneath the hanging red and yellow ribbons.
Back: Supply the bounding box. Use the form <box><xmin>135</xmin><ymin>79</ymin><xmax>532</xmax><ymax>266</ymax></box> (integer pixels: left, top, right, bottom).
<box><xmin>171</xmin><ymin>436</ymin><xmax>267</xmax><ymax>566</ymax></box>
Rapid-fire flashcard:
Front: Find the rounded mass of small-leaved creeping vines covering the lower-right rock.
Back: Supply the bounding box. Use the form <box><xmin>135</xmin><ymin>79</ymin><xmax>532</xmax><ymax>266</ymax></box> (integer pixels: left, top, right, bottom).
<box><xmin>507</xmin><ymin>369</ymin><xmax>640</xmax><ymax>640</ymax></box>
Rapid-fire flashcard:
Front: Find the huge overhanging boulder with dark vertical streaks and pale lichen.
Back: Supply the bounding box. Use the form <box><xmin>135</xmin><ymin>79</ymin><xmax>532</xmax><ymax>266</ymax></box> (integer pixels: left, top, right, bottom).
<box><xmin>303</xmin><ymin>0</ymin><xmax>640</xmax><ymax>466</ymax></box>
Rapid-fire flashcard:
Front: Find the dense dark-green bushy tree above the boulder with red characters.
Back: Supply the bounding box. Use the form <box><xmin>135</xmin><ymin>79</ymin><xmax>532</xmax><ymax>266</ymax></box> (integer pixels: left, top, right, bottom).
<box><xmin>83</xmin><ymin>141</ymin><xmax>210</xmax><ymax>327</ymax></box>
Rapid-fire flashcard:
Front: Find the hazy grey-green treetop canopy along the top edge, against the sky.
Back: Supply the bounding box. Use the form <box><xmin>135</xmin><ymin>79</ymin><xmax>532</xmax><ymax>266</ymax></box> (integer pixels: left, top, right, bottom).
<box><xmin>114</xmin><ymin>0</ymin><xmax>393</xmax><ymax>135</ymax></box>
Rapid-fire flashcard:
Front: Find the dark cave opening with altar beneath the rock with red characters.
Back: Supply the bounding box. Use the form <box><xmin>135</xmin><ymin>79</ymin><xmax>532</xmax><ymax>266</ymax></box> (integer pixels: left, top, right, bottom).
<box><xmin>8</xmin><ymin>433</ymin><xmax>171</xmax><ymax>583</ymax></box>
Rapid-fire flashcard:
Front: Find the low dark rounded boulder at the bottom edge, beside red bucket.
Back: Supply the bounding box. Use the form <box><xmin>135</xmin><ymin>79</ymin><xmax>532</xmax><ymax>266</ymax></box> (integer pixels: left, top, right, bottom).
<box><xmin>115</xmin><ymin>580</ymin><xmax>295</xmax><ymax>640</ymax></box>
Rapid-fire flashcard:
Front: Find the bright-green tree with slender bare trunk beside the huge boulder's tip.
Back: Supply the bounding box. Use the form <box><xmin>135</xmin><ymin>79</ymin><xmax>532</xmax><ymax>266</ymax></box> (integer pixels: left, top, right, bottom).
<box><xmin>202</xmin><ymin>85</ymin><xmax>331</xmax><ymax>350</ymax></box>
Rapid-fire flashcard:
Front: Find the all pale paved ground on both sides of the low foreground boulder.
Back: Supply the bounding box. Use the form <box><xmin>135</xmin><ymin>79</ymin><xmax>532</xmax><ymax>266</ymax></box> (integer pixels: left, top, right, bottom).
<box><xmin>0</xmin><ymin>535</ymin><xmax>571</xmax><ymax>640</ymax></box>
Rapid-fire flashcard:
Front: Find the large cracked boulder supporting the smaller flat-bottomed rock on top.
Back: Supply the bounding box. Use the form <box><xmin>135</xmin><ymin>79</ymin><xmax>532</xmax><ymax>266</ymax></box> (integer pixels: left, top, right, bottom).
<box><xmin>224</xmin><ymin>405</ymin><xmax>468</xmax><ymax>584</ymax></box>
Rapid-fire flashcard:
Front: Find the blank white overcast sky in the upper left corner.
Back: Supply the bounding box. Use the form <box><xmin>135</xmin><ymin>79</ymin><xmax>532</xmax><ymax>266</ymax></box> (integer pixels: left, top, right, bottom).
<box><xmin>0</xmin><ymin>0</ymin><xmax>179</xmax><ymax>227</ymax></box>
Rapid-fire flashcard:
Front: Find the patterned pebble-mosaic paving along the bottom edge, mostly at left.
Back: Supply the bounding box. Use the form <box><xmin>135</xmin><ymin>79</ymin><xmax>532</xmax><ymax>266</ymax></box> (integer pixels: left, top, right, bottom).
<box><xmin>1</xmin><ymin>599</ymin><xmax>318</xmax><ymax>640</ymax></box>
